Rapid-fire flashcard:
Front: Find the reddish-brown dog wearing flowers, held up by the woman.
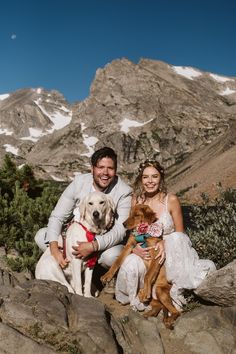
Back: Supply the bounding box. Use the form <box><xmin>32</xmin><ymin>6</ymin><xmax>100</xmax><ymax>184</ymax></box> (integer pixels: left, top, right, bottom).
<box><xmin>101</xmin><ymin>204</ymin><xmax>180</xmax><ymax>328</ymax></box>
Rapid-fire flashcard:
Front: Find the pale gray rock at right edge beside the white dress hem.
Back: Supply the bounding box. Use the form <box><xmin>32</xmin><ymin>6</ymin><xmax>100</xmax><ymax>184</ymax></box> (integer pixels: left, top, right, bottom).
<box><xmin>195</xmin><ymin>260</ymin><xmax>236</xmax><ymax>306</ymax></box>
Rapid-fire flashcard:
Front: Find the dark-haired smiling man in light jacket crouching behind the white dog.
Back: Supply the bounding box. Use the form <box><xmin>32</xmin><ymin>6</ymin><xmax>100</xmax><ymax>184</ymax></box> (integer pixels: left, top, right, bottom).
<box><xmin>35</xmin><ymin>147</ymin><xmax>132</xmax><ymax>276</ymax></box>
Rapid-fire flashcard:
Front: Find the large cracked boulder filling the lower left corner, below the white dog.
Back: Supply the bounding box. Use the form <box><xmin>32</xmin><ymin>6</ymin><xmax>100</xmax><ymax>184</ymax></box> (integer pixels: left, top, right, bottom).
<box><xmin>0</xmin><ymin>281</ymin><xmax>118</xmax><ymax>354</ymax></box>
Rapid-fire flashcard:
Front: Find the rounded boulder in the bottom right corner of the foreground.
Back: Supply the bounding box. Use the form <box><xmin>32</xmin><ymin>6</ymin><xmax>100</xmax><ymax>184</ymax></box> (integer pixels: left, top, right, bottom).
<box><xmin>170</xmin><ymin>306</ymin><xmax>236</xmax><ymax>354</ymax></box>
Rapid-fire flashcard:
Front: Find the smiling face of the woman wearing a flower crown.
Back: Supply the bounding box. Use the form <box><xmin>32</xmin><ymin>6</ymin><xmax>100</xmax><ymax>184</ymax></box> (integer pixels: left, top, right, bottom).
<box><xmin>142</xmin><ymin>166</ymin><xmax>161</xmax><ymax>194</ymax></box>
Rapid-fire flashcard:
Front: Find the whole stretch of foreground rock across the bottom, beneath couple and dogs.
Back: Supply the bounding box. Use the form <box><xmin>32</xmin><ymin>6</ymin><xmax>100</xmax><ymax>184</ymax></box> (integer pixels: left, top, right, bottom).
<box><xmin>0</xmin><ymin>270</ymin><xmax>236</xmax><ymax>354</ymax></box>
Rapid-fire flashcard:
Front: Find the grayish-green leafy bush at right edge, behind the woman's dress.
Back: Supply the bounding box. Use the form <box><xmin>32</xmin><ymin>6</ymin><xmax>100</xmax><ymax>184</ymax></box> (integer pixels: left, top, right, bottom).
<box><xmin>187</xmin><ymin>189</ymin><xmax>236</xmax><ymax>269</ymax></box>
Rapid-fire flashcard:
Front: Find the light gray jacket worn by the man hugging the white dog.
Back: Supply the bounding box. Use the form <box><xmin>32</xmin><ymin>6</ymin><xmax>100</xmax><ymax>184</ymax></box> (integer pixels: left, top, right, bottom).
<box><xmin>45</xmin><ymin>173</ymin><xmax>132</xmax><ymax>250</ymax></box>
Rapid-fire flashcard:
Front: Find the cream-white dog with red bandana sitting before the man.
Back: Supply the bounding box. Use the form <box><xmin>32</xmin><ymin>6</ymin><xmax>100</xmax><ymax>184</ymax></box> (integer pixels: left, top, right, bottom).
<box><xmin>35</xmin><ymin>192</ymin><xmax>114</xmax><ymax>297</ymax></box>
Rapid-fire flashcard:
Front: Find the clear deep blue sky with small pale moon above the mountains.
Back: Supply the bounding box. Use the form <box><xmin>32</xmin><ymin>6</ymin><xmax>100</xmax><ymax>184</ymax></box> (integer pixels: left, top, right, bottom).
<box><xmin>0</xmin><ymin>0</ymin><xmax>236</xmax><ymax>102</ymax></box>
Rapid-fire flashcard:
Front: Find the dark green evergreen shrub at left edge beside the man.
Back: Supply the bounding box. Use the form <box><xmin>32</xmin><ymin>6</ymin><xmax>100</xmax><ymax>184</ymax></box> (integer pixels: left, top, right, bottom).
<box><xmin>0</xmin><ymin>155</ymin><xmax>62</xmax><ymax>273</ymax></box>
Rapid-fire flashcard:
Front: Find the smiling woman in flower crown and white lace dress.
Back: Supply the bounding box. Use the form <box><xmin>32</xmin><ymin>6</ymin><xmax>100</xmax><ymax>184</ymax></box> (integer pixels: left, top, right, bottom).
<box><xmin>115</xmin><ymin>160</ymin><xmax>216</xmax><ymax>311</ymax></box>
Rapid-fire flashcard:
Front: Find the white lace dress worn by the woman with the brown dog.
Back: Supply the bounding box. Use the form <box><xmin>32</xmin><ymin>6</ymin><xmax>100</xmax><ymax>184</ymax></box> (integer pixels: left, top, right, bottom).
<box><xmin>115</xmin><ymin>195</ymin><xmax>216</xmax><ymax>311</ymax></box>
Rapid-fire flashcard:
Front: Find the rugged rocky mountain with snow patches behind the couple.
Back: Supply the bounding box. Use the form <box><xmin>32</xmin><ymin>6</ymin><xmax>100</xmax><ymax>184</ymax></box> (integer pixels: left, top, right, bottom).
<box><xmin>0</xmin><ymin>59</ymin><xmax>236</xmax><ymax>201</ymax></box>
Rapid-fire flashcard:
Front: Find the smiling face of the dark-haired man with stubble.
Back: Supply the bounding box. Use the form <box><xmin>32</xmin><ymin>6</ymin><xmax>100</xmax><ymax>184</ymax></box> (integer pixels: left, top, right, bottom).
<box><xmin>91</xmin><ymin>157</ymin><xmax>116</xmax><ymax>191</ymax></box>
